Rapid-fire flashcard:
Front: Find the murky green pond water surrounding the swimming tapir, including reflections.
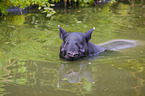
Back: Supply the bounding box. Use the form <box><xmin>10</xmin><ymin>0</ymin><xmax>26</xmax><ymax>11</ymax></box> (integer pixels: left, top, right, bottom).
<box><xmin>0</xmin><ymin>3</ymin><xmax>145</xmax><ymax>96</ymax></box>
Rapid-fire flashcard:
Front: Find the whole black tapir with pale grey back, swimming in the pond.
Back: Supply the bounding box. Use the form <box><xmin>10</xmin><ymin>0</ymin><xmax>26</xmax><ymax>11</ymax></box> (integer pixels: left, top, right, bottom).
<box><xmin>58</xmin><ymin>25</ymin><xmax>136</xmax><ymax>61</ymax></box>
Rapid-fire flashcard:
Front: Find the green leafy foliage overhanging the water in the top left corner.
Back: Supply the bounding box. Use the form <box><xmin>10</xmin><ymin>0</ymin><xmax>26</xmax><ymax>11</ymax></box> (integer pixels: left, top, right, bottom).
<box><xmin>0</xmin><ymin>0</ymin><xmax>56</xmax><ymax>17</ymax></box>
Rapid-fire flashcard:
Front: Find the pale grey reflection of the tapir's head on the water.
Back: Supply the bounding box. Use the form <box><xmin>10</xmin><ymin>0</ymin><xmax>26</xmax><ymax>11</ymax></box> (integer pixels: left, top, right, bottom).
<box><xmin>58</xmin><ymin>64</ymin><xmax>93</xmax><ymax>87</ymax></box>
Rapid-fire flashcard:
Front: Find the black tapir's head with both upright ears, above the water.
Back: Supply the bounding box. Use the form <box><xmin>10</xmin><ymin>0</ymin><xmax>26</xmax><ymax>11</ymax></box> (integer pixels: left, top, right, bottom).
<box><xmin>58</xmin><ymin>25</ymin><xmax>95</xmax><ymax>61</ymax></box>
